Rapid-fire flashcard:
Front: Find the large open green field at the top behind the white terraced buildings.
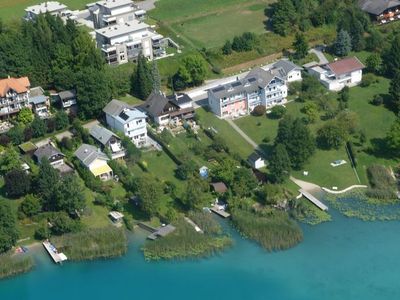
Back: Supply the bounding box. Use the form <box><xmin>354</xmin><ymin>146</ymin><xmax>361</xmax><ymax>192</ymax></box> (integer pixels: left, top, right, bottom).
<box><xmin>149</xmin><ymin>0</ymin><xmax>274</xmax><ymax>48</ymax></box>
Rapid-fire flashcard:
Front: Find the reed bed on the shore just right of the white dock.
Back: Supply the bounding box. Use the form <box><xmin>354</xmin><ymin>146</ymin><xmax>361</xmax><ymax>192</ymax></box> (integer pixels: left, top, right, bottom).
<box><xmin>52</xmin><ymin>226</ymin><xmax>128</xmax><ymax>260</ymax></box>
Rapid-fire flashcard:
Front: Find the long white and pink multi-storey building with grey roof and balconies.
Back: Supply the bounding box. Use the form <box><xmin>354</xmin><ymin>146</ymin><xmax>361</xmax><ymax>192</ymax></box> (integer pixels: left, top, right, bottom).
<box><xmin>208</xmin><ymin>68</ymin><xmax>287</xmax><ymax>118</ymax></box>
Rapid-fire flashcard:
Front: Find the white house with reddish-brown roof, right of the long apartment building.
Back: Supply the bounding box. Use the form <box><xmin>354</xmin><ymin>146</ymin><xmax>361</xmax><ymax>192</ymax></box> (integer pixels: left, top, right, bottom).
<box><xmin>308</xmin><ymin>57</ymin><xmax>365</xmax><ymax>91</ymax></box>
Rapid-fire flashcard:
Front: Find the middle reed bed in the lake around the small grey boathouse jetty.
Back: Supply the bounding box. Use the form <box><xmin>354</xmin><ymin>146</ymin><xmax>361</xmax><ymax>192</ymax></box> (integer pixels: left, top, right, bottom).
<box><xmin>143</xmin><ymin>216</ymin><xmax>232</xmax><ymax>260</ymax></box>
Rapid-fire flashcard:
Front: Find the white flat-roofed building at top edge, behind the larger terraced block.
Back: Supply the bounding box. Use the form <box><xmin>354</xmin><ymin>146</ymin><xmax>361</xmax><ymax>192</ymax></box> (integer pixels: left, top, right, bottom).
<box><xmin>89</xmin><ymin>0</ymin><xmax>141</xmax><ymax>29</ymax></box>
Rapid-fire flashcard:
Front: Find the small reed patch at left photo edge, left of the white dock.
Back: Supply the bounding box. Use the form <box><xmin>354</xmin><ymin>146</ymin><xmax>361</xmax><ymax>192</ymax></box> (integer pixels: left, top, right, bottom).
<box><xmin>0</xmin><ymin>254</ymin><xmax>34</xmax><ymax>279</ymax></box>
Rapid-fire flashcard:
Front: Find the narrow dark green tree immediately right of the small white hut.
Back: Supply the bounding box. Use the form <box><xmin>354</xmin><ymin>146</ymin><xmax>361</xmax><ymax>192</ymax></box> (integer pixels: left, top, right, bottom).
<box><xmin>268</xmin><ymin>144</ymin><xmax>290</xmax><ymax>183</ymax></box>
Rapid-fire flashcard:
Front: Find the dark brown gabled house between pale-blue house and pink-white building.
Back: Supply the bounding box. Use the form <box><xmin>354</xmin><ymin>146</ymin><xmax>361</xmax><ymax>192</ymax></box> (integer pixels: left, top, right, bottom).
<box><xmin>140</xmin><ymin>92</ymin><xmax>195</xmax><ymax>125</ymax></box>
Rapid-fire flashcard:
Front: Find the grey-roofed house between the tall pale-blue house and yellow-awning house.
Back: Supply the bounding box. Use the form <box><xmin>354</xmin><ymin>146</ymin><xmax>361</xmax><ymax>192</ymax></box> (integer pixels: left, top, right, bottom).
<box><xmin>89</xmin><ymin>125</ymin><xmax>125</xmax><ymax>159</ymax></box>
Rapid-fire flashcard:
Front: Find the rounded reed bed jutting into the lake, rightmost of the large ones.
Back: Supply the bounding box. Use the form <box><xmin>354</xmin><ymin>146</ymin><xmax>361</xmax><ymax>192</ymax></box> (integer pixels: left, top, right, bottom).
<box><xmin>232</xmin><ymin>209</ymin><xmax>303</xmax><ymax>251</ymax></box>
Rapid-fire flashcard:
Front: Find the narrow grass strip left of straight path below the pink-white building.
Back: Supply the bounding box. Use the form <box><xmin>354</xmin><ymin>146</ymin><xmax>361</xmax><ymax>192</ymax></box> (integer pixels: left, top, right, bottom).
<box><xmin>196</xmin><ymin>108</ymin><xmax>254</xmax><ymax>159</ymax></box>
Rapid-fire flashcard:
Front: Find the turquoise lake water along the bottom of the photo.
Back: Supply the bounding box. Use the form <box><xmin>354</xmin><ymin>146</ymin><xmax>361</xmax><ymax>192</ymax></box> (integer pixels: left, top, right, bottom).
<box><xmin>0</xmin><ymin>211</ymin><xmax>400</xmax><ymax>300</ymax></box>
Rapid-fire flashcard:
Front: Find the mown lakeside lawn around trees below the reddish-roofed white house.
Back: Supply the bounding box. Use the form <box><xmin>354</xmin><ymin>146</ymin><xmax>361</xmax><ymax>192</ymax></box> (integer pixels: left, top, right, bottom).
<box><xmin>235</xmin><ymin>75</ymin><xmax>398</xmax><ymax>189</ymax></box>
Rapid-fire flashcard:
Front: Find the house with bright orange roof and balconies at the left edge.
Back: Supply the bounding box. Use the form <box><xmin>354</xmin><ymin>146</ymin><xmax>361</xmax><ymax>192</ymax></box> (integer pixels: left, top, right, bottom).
<box><xmin>0</xmin><ymin>77</ymin><xmax>31</xmax><ymax>119</ymax></box>
